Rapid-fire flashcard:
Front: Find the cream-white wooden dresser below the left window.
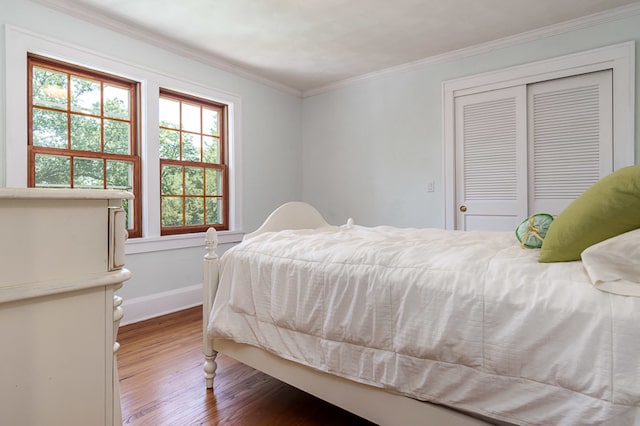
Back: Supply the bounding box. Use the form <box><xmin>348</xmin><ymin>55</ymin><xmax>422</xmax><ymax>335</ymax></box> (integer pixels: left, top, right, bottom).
<box><xmin>0</xmin><ymin>188</ymin><xmax>132</xmax><ymax>426</ymax></box>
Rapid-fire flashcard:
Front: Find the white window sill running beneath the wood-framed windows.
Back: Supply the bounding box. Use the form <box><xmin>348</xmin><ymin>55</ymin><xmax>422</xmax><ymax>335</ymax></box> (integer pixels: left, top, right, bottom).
<box><xmin>125</xmin><ymin>230</ymin><xmax>244</xmax><ymax>256</ymax></box>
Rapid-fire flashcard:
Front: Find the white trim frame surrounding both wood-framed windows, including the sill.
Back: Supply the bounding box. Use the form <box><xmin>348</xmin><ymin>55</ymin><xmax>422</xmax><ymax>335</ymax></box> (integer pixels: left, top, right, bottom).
<box><xmin>0</xmin><ymin>25</ymin><xmax>244</xmax><ymax>254</ymax></box>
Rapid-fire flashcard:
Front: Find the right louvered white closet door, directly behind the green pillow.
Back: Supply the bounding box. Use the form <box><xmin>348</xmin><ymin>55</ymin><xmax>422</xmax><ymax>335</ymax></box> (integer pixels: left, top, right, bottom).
<box><xmin>528</xmin><ymin>70</ymin><xmax>613</xmax><ymax>215</ymax></box>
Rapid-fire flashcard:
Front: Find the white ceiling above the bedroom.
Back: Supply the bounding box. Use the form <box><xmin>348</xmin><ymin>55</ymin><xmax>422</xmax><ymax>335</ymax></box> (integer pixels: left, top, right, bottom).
<box><xmin>39</xmin><ymin>0</ymin><xmax>640</xmax><ymax>94</ymax></box>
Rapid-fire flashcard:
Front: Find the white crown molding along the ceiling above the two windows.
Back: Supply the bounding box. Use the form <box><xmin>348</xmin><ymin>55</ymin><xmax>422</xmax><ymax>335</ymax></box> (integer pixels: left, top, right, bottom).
<box><xmin>27</xmin><ymin>0</ymin><xmax>302</xmax><ymax>97</ymax></box>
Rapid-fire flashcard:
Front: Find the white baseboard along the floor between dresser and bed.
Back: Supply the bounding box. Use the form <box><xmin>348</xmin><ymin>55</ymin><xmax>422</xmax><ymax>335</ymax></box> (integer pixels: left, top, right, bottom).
<box><xmin>120</xmin><ymin>284</ymin><xmax>202</xmax><ymax>326</ymax></box>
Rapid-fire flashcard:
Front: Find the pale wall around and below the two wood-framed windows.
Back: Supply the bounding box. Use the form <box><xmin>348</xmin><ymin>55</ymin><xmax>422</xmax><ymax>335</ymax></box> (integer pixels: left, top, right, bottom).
<box><xmin>0</xmin><ymin>0</ymin><xmax>302</xmax><ymax>310</ymax></box>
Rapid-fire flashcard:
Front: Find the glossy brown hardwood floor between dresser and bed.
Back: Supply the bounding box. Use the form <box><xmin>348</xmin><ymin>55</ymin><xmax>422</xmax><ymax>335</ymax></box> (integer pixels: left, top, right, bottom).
<box><xmin>118</xmin><ymin>307</ymin><xmax>371</xmax><ymax>426</ymax></box>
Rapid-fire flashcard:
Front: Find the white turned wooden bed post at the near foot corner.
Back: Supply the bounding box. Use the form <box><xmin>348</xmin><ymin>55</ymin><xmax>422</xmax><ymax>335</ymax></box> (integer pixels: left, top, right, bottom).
<box><xmin>202</xmin><ymin>228</ymin><xmax>220</xmax><ymax>389</ymax></box>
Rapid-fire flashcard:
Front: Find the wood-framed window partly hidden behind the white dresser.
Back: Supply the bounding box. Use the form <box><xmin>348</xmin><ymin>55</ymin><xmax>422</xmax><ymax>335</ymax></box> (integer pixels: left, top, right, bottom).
<box><xmin>27</xmin><ymin>55</ymin><xmax>141</xmax><ymax>237</ymax></box>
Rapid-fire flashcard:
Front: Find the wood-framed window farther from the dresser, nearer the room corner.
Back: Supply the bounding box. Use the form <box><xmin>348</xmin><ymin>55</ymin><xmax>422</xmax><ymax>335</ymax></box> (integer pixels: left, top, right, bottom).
<box><xmin>159</xmin><ymin>89</ymin><xmax>229</xmax><ymax>235</ymax></box>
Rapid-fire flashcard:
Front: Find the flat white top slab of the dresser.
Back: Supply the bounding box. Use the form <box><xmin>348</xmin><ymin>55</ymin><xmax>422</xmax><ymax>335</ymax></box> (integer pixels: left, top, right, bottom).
<box><xmin>0</xmin><ymin>188</ymin><xmax>133</xmax><ymax>200</ymax></box>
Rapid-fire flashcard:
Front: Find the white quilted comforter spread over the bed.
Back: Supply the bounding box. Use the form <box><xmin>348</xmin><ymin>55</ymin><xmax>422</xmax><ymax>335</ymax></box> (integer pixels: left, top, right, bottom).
<box><xmin>209</xmin><ymin>226</ymin><xmax>640</xmax><ymax>425</ymax></box>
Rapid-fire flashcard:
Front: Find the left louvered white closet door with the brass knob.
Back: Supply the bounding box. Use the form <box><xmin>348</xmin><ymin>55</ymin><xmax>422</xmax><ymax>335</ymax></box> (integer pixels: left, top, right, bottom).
<box><xmin>455</xmin><ymin>86</ymin><xmax>527</xmax><ymax>231</ymax></box>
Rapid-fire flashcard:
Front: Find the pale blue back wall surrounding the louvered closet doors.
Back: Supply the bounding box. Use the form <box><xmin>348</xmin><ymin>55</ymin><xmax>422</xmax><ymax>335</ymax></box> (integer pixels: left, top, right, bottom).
<box><xmin>302</xmin><ymin>12</ymin><xmax>640</xmax><ymax>227</ymax></box>
